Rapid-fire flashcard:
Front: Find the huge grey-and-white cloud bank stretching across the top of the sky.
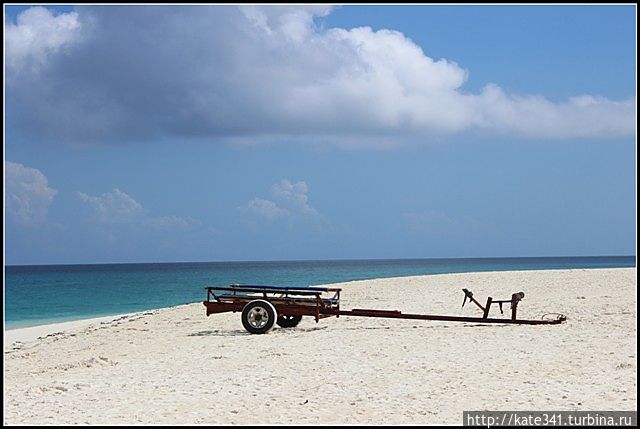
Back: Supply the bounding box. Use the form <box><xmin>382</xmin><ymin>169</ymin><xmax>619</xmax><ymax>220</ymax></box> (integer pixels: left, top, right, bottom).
<box><xmin>6</xmin><ymin>6</ymin><xmax>636</xmax><ymax>144</ymax></box>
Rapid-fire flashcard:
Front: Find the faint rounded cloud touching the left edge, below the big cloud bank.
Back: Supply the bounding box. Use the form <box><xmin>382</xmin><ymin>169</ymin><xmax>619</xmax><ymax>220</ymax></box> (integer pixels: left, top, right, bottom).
<box><xmin>4</xmin><ymin>161</ymin><xmax>58</xmax><ymax>226</ymax></box>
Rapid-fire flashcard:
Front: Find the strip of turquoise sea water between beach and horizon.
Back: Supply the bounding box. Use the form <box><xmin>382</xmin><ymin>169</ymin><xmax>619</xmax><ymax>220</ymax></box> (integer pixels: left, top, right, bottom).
<box><xmin>4</xmin><ymin>256</ymin><xmax>636</xmax><ymax>329</ymax></box>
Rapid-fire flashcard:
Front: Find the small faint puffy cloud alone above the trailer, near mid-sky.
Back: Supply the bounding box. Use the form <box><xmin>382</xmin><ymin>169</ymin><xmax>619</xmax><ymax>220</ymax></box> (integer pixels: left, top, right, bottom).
<box><xmin>241</xmin><ymin>179</ymin><xmax>319</xmax><ymax>220</ymax></box>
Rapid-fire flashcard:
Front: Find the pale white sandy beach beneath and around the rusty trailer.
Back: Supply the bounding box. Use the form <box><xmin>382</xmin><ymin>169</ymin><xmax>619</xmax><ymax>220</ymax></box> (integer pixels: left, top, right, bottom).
<box><xmin>4</xmin><ymin>268</ymin><xmax>637</xmax><ymax>424</ymax></box>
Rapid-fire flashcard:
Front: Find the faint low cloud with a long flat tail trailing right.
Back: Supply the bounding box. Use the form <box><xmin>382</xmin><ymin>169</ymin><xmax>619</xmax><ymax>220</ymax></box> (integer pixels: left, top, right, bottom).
<box><xmin>77</xmin><ymin>188</ymin><xmax>200</xmax><ymax>229</ymax></box>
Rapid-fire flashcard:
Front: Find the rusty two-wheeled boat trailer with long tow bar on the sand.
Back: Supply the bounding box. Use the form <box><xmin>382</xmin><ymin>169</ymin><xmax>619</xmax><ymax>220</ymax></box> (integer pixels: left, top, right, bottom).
<box><xmin>203</xmin><ymin>284</ymin><xmax>567</xmax><ymax>334</ymax></box>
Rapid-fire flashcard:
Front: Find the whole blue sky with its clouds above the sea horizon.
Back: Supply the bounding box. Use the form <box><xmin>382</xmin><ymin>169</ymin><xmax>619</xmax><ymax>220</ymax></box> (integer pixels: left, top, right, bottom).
<box><xmin>4</xmin><ymin>5</ymin><xmax>636</xmax><ymax>265</ymax></box>
